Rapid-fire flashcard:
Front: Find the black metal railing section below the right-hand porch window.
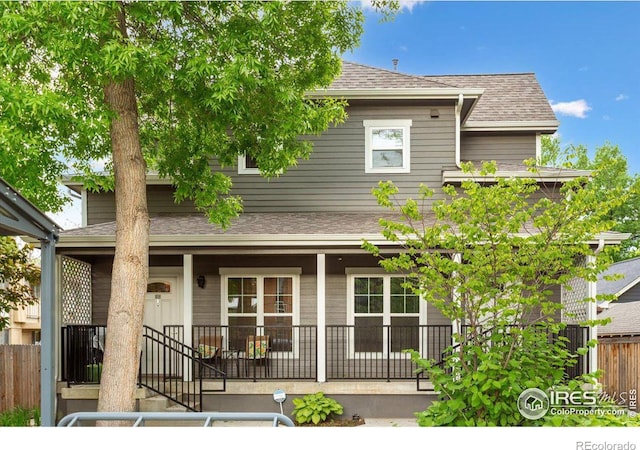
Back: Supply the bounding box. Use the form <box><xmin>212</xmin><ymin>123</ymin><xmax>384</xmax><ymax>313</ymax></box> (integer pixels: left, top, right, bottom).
<box><xmin>326</xmin><ymin>325</ymin><xmax>452</xmax><ymax>381</ymax></box>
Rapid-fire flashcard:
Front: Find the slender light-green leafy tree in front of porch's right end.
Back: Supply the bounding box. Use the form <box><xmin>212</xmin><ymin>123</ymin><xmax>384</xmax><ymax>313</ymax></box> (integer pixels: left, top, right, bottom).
<box><xmin>363</xmin><ymin>163</ymin><xmax>627</xmax><ymax>426</ymax></box>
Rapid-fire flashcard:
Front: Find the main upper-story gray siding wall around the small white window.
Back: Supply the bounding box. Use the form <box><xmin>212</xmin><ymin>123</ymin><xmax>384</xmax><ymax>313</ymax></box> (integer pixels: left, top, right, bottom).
<box><xmin>87</xmin><ymin>105</ymin><xmax>455</xmax><ymax>225</ymax></box>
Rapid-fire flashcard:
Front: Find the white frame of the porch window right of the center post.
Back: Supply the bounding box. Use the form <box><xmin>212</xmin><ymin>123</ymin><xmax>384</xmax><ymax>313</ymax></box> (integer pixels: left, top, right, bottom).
<box><xmin>346</xmin><ymin>268</ymin><xmax>427</xmax><ymax>359</ymax></box>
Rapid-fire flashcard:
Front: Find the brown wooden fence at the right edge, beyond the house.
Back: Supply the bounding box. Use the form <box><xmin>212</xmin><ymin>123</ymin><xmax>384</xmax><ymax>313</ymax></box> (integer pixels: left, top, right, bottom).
<box><xmin>598</xmin><ymin>336</ymin><xmax>640</xmax><ymax>411</ymax></box>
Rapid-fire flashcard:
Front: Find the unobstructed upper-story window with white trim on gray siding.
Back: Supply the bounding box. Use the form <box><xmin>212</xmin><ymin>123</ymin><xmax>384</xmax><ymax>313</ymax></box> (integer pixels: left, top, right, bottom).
<box><xmin>363</xmin><ymin>119</ymin><xmax>411</xmax><ymax>173</ymax></box>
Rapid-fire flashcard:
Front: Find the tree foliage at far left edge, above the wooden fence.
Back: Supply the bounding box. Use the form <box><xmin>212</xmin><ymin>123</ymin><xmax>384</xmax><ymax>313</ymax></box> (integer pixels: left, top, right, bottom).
<box><xmin>0</xmin><ymin>236</ymin><xmax>40</xmax><ymax>331</ymax></box>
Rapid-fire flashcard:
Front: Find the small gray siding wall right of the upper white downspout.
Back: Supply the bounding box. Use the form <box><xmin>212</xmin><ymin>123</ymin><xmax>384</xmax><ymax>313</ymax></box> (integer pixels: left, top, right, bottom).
<box><xmin>460</xmin><ymin>132</ymin><xmax>536</xmax><ymax>164</ymax></box>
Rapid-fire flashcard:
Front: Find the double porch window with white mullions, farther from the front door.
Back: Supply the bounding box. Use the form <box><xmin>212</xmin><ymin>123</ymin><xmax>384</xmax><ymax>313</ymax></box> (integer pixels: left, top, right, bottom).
<box><xmin>348</xmin><ymin>274</ymin><xmax>421</xmax><ymax>355</ymax></box>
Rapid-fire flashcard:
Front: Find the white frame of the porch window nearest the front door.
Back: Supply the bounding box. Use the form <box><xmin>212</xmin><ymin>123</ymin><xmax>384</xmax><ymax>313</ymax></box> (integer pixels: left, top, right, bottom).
<box><xmin>219</xmin><ymin>267</ymin><xmax>302</xmax><ymax>358</ymax></box>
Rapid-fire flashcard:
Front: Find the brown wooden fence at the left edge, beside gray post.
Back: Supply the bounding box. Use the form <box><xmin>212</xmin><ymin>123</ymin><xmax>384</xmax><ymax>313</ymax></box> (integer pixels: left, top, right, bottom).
<box><xmin>0</xmin><ymin>345</ymin><xmax>40</xmax><ymax>412</ymax></box>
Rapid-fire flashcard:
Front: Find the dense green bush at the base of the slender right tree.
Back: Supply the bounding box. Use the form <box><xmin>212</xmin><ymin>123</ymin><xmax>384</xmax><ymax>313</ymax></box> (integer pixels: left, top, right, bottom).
<box><xmin>411</xmin><ymin>327</ymin><xmax>588</xmax><ymax>427</ymax></box>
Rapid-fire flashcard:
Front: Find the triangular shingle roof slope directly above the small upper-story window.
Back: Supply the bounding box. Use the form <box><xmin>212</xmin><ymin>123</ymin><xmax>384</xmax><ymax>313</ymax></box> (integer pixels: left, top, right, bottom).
<box><xmin>329</xmin><ymin>61</ymin><xmax>457</xmax><ymax>89</ymax></box>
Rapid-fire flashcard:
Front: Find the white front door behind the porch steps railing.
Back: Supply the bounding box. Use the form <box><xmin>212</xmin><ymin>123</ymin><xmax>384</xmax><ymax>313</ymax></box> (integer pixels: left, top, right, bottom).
<box><xmin>142</xmin><ymin>272</ymin><xmax>184</xmax><ymax>375</ymax></box>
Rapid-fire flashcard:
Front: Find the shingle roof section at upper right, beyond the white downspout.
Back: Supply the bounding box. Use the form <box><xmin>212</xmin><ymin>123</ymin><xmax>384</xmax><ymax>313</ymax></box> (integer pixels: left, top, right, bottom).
<box><xmin>424</xmin><ymin>73</ymin><xmax>557</xmax><ymax>126</ymax></box>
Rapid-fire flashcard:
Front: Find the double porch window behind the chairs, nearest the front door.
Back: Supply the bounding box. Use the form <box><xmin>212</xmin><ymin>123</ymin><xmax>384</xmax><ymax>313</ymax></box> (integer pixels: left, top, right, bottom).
<box><xmin>222</xmin><ymin>273</ymin><xmax>300</xmax><ymax>352</ymax></box>
